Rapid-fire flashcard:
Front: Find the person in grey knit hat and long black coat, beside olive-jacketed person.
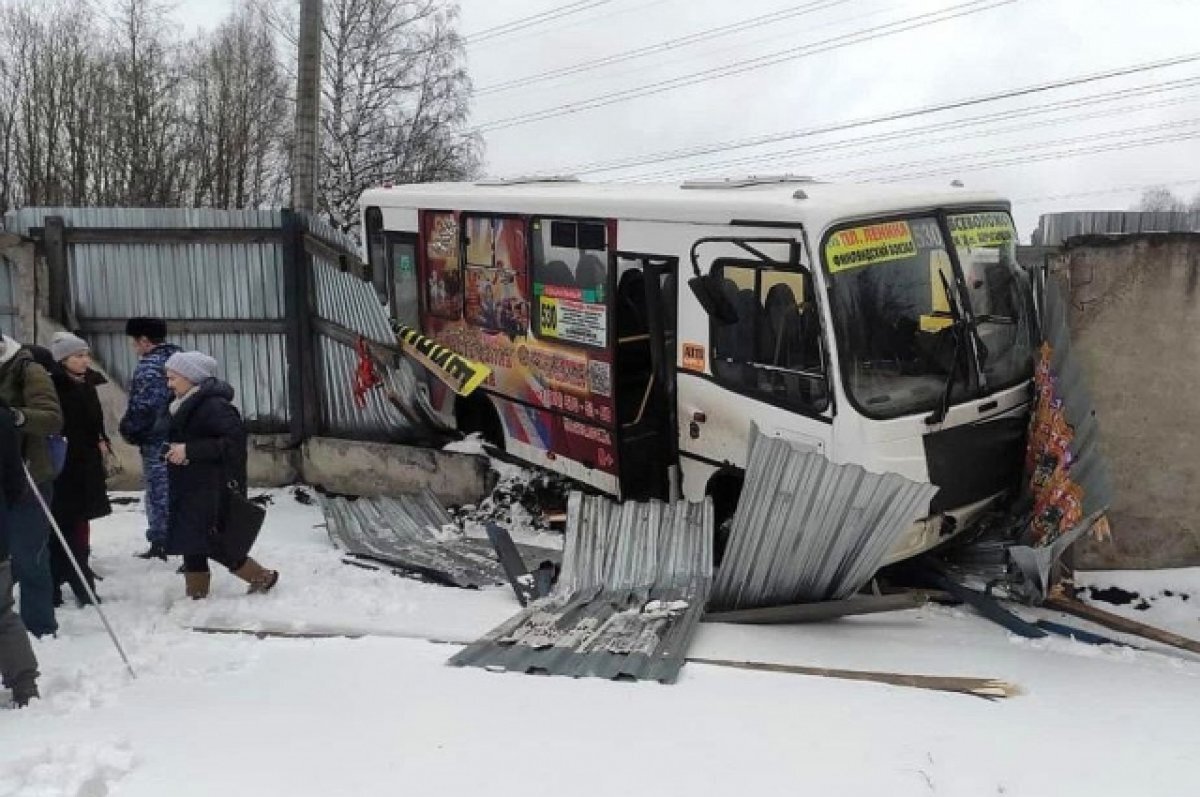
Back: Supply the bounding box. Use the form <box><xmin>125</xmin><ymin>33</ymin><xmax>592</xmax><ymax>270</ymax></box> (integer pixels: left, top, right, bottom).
<box><xmin>30</xmin><ymin>332</ymin><xmax>113</xmax><ymax>606</ymax></box>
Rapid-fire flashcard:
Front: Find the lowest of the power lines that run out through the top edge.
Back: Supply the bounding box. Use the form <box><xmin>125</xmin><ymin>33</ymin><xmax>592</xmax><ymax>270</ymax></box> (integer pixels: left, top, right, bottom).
<box><xmin>475</xmin><ymin>0</ymin><xmax>1018</xmax><ymax>132</ymax></box>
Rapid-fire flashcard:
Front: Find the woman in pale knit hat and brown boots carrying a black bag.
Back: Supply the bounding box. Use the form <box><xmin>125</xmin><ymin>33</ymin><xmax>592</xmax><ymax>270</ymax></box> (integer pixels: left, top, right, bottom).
<box><xmin>164</xmin><ymin>352</ymin><xmax>280</xmax><ymax>600</ymax></box>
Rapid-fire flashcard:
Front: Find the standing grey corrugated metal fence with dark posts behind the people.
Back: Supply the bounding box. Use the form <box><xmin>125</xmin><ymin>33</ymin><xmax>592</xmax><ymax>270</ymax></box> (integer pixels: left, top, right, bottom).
<box><xmin>0</xmin><ymin>208</ymin><xmax>410</xmax><ymax>441</ymax></box>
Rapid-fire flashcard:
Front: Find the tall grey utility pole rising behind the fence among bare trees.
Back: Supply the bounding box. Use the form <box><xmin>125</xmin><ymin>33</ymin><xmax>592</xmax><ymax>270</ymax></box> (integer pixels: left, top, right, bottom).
<box><xmin>292</xmin><ymin>0</ymin><xmax>322</xmax><ymax>211</ymax></box>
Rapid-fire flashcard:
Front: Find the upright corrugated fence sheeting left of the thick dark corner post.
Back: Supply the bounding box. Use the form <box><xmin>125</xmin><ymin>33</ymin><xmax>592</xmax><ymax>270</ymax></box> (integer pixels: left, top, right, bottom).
<box><xmin>6</xmin><ymin>208</ymin><xmax>289</xmax><ymax>426</ymax></box>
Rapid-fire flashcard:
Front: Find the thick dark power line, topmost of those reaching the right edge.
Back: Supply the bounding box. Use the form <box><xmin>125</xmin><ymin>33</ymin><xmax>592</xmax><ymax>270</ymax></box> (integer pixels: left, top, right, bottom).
<box><xmin>554</xmin><ymin>53</ymin><xmax>1200</xmax><ymax>174</ymax></box>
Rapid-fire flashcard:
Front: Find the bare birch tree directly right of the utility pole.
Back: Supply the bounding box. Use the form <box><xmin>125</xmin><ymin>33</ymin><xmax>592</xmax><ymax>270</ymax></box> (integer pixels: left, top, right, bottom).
<box><xmin>256</xmin><ymin>0</ymin><xmax>482</xmax><ymax>229</ymax></box>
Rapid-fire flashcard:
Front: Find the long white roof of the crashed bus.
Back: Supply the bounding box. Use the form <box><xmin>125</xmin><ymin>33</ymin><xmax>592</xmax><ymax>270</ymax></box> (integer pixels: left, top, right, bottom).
<box><xmin>359</xmin><ymin>179</ymin><xmax>1009</xmax><ymax>229</ymax></box>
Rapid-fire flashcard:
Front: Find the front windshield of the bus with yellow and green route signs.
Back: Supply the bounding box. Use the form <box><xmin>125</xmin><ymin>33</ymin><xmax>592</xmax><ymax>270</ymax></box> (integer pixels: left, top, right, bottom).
<box><xmin>824</xmin><ymin>212</ymin><xmax>1032</xmax><ymax>419</ymax></box>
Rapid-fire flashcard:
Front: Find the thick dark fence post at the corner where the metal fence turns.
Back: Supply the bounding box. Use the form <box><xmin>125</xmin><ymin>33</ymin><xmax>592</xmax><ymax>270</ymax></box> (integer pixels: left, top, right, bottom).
<box><xmin>282</xmin><ymin>210</ymin><xmax>320</xmax><ymax>447</ymax></box>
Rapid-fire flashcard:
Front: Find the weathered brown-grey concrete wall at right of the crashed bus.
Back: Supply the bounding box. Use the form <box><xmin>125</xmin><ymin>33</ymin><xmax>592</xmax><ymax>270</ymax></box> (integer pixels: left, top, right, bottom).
<box><xmin>1054</xmin><ymin>234</ymin><xmax>1200</xmax><ymax>569</ymax></box>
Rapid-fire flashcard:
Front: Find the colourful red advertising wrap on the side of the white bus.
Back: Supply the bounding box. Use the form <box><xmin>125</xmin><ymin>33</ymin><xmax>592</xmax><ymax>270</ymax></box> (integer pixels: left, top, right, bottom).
<box><xmin>422</xmin><ymin>212</ymin><xmax>616</xmax><ymax>473</ymax></box>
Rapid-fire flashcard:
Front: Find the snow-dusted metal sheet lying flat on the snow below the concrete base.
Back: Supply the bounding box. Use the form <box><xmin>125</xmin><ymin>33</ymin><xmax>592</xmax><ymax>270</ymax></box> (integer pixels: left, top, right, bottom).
<box><xmin>320</xmin><ymin>491</ymin><xmax>557</xmax><ymax>588</ymax></box>
